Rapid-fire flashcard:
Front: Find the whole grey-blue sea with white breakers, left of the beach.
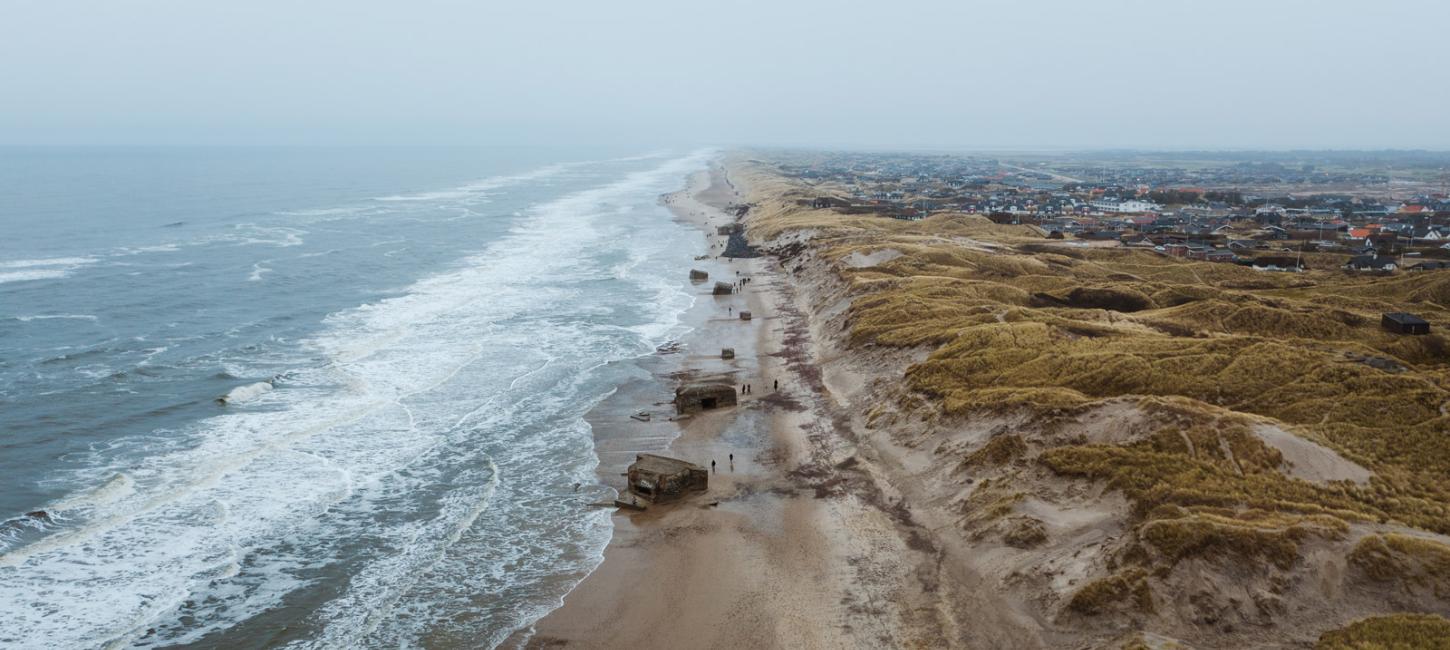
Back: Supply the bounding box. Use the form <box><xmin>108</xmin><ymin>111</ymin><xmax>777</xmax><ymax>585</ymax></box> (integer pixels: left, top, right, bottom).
<box><xmin>0</xmin><ymin>147</ymin><xmax>713</xmax><ymax>649</ymax></box>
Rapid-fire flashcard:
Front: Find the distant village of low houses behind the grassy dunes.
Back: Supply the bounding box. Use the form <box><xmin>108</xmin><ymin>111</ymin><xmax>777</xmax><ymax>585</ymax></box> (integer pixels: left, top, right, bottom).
<box><xmin>783</xmin><ymin>154</ymin><xmax>1450</xmax><ymax>273</ymax></box>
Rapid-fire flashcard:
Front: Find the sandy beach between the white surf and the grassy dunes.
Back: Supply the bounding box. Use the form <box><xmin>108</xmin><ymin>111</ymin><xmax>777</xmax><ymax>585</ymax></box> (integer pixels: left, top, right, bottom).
<box><xmin>510</xmin><ymin>159</ymin><xmax>945</xmax><ymax>647</ymax></box>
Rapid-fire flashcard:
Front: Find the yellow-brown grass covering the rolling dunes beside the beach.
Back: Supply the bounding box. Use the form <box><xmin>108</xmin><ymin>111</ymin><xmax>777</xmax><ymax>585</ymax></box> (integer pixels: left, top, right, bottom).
<box><xmin>737</xmin><ymin>153</ymin><xmax>1450</xmax><ymax>647</ymax></box>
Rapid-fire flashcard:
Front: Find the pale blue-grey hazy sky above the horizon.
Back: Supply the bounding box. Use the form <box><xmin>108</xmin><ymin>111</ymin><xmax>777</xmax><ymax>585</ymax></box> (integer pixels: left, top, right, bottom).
<box><xmin>0</xmin><ymin>0</ymin><xmax>1450</xmax><ymax>149</ymax></box>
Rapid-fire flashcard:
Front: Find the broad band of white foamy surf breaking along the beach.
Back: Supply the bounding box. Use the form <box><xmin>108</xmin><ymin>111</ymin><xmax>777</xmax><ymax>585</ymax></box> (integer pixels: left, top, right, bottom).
<box><xmin>0</xmin><ymin>152</ymin><xmax>708</xmax><ymax>647</ymax></box>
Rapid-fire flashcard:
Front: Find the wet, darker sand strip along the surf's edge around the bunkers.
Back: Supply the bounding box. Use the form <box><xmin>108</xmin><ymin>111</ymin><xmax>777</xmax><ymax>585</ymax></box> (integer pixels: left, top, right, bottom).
<box><xmin>503</xmin><ymin>161</ymin><xmax>779</xmax><ymax>647</ymax></box>
